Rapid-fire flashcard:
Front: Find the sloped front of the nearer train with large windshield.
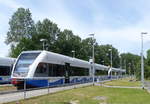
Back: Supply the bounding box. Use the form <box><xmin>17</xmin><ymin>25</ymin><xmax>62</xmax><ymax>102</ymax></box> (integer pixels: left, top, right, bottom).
<box><xmin>11</xmin><ymin>52</ymin><xmax>40</xmax><ymax>89</ymax></box>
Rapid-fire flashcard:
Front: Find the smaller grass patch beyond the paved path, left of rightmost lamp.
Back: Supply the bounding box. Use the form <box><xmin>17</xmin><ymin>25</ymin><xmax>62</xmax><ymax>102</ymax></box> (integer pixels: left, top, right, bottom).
<box><xmin>104</xmin><ymin>78</ymin><xmax>141</xmax><ymax>87</ymax></box>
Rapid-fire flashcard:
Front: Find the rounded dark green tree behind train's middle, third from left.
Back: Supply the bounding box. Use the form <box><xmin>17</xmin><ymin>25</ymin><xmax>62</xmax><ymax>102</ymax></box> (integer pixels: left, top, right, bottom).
<box><xmin>56</xmin><ymin>29</ymin><xmax>81</xmax><ymax>58</ymax></box>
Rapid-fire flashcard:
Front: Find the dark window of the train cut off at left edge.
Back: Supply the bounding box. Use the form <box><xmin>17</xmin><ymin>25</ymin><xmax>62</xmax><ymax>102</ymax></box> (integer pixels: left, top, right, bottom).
<box><xmin>0</xmin><ymin>66</ymin><xmax>11</xmax><ymax>76</ymax></box>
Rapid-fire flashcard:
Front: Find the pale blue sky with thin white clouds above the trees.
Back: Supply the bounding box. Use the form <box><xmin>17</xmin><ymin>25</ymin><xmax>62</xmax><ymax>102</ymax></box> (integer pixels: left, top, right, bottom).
<box><xmin>0</xmin><ymin>0</ymin><xmax>150</xmax><ymax>56</ymax></box>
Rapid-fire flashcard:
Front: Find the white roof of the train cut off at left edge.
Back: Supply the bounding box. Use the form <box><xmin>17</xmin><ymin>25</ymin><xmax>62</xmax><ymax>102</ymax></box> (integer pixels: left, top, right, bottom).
<box><xmin>0</xmin><ymin>57</ymin><xmax>16</xmax><ymax>66</ymax></box>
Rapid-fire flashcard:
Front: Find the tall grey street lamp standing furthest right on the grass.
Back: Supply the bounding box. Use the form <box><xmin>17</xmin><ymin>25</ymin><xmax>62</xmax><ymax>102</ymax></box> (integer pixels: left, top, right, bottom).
<box><xmin>141</xmin><ymin>32</ymin><xmax>148</xmax><ymax>89</ymax></box>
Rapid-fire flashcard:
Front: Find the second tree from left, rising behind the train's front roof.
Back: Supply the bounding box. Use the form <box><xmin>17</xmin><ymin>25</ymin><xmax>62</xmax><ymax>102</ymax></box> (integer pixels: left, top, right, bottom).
<box><xmin>33</xmin><ymin>19</ymin><xmax>60</xmax><ymax>52</ymax></box>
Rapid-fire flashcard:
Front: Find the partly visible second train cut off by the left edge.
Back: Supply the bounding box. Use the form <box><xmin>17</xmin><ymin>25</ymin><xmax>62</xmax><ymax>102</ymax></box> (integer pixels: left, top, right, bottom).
<box><xmin>0</xmin><ymin>57</ymin><xmax>16</xmax><ymax>84</ymax></box>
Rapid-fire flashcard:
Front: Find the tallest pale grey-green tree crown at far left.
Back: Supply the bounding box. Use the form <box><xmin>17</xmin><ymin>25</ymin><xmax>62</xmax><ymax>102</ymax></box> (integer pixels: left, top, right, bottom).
<box><xmin>5</xmin><ymin>8</ymin><xmax>35</xmax><ymax>44</ymax></box>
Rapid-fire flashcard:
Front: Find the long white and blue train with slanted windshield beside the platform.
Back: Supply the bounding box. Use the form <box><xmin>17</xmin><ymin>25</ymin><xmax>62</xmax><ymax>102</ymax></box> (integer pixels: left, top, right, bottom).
<box><xmin>11</xmin><ymin>51</ymin><xmax>125</xmax><ymax>88</ymax></box>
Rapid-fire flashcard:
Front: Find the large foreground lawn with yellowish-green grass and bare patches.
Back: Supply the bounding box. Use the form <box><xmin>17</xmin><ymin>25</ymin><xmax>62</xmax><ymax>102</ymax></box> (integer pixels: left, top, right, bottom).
<box><xmin>7</xmin><ymin>86</ymin><xmax>150</xmax><ymax>104</ymax></box>
